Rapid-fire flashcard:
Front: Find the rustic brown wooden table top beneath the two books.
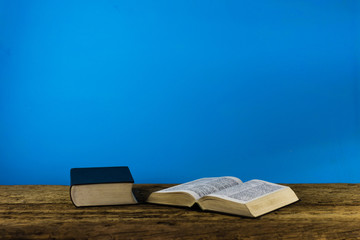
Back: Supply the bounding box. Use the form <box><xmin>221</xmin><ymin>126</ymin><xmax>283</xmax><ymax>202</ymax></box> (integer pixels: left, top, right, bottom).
<box><xmin>0</xmin><ymin>184</ymin><xmax>360</xmax><ymax>240</ymax></box>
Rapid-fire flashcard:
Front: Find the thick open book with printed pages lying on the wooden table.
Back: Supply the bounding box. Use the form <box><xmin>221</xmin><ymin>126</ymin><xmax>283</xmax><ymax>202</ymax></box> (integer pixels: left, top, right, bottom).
<box><xmin>147</xmin><ymin>177</ymin><xmax>299</xmax><ymax>217</ymax></box>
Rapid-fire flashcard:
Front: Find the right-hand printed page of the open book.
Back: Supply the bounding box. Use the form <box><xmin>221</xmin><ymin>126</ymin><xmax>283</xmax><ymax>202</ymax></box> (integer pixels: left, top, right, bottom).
<box><xmin>209</xmin><ymin>180</ymin><xmax>287</xmax><ymax>203</ymax></box>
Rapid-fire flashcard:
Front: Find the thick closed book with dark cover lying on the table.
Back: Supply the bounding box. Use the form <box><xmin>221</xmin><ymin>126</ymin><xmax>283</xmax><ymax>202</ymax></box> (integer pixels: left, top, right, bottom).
<box><xmin>70</xmin><ymin>167</ymin><xmax>137</xmax><ymax>207</ymax></box>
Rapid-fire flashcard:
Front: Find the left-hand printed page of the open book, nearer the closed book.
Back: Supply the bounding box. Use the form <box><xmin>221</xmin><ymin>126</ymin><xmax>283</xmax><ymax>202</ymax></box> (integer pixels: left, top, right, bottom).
<box><xmin>158</xmin><ymin>177</ymin><xmax>242</xmax><ymax>200</ymax></box>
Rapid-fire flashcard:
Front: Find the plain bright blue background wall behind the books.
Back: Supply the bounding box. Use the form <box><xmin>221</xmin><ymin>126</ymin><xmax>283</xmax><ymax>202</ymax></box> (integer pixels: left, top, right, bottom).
<box><xmin>0</xmin><ymin>0</ymin><xmax>360</xmax><ymax>184</ymax></box>
